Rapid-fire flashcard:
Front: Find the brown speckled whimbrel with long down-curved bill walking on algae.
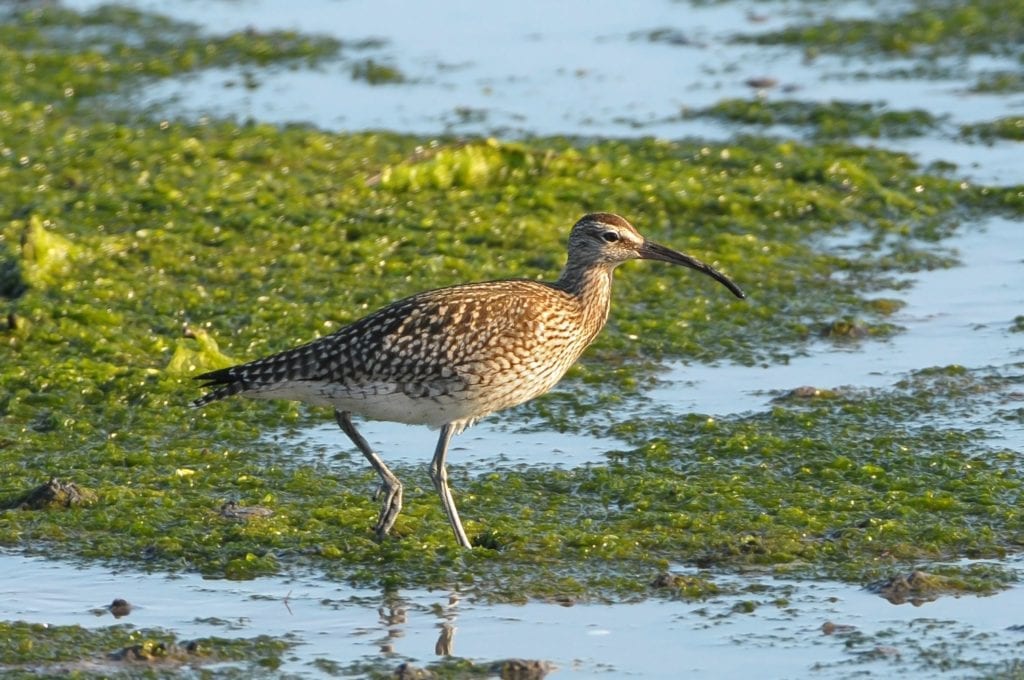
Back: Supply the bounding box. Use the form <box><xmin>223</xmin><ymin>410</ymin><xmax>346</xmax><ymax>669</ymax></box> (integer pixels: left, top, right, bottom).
<box><xmin>193</xmin><ymin>213</ymin><xmax>744</xmax><ymax>548</ymax></box>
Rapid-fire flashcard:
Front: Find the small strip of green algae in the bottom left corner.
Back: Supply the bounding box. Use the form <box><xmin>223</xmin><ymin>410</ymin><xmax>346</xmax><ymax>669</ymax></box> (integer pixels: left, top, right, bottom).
<box><xmin>0</xmin><ymin>622</ymin><xmax>292</xmax><ymax>678</ymax></box>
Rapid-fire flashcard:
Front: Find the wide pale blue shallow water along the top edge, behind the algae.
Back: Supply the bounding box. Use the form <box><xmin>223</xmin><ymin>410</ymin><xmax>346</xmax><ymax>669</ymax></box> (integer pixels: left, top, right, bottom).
<box><xmin>68</xmin><ymin>0</ymin><xmax>1021</xmax><ymax>143</ymax></box>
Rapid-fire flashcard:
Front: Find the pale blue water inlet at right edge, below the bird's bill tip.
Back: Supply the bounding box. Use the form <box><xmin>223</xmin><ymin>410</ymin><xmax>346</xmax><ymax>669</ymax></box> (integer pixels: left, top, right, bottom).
<box><xmin>648</xmin><ymin>217</ymin><xmax>1024</xmax><ymax>419</ymax></box>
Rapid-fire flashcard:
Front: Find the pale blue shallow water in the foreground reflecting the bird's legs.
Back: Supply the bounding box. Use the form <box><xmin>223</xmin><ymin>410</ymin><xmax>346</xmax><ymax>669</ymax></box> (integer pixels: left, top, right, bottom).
<box><xmin>0</xmin><ymin>553</ymin><xmax>1024</xmax><ymax>678</ymax></box>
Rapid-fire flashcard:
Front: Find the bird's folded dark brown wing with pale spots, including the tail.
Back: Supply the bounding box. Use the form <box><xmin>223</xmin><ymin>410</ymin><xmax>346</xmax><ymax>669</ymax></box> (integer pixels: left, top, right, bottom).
<box><xmin>195</xmin><ymin>281</ymin><xmax>569</xmax><ymax>406</ymax></box>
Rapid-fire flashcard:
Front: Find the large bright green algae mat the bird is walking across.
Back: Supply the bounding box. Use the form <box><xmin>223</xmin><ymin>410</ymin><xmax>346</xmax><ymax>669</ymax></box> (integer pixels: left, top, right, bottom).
<box><xmin>0</xmin><ymin>1</ymin><xmax>1024</xmax><ymax>601</ymax></box>
